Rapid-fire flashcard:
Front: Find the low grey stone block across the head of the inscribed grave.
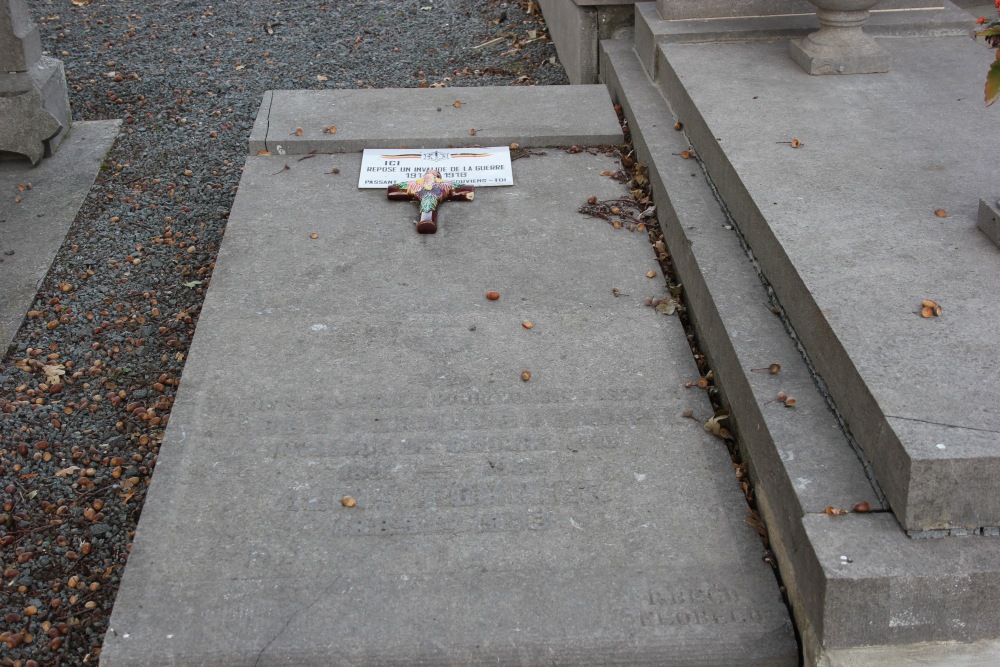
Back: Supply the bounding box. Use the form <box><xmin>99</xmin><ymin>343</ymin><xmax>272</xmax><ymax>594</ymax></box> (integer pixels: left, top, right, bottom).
<box><xmin>250</xmin><ymin>85</ymin><xmax>621</xmax><ymax>155</ymax></box>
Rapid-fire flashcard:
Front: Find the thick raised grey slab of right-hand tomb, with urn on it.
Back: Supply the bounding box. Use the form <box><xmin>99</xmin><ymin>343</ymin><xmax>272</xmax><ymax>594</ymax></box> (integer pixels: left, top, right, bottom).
<box><xmin>660</xmin><ymin>37</ymin><xmax>1000</xmax><ymax>531</ymax></box>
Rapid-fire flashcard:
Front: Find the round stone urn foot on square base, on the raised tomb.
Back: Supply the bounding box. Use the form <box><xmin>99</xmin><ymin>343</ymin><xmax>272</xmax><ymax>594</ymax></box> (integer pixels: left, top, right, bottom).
<box><xmin>788</xmin><ymin>0</ymin><xmax>889</xmax><ymax>74</ymax></box>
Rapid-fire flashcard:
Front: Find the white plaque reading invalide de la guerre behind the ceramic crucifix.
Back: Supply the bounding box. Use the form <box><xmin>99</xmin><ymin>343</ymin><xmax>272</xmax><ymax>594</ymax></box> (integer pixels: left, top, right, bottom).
<box><xmin>358</xmin><ymin>146</ymin><xmax>514</xmax><ymax>188</ymax></box>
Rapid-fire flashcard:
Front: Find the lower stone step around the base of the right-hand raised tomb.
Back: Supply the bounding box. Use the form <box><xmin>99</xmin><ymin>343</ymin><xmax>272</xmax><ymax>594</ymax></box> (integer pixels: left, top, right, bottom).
<box><xmin>601</xmin><ymin>35</ymin><xmax>1000</xmax><ymax>666</ymax></box>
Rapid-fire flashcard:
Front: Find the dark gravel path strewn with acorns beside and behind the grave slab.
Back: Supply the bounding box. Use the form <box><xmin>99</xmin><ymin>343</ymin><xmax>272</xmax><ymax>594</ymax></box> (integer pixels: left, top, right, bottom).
<box><xmin>0</xmin><ymin>0</ymin><xmax>568</xmax><ymax>667</ymax></box>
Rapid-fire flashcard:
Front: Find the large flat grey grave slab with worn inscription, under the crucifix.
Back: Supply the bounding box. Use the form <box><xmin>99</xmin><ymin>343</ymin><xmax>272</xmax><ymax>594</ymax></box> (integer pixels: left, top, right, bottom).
<box><xmin>101</xmin><ymin>142</ymin><xmax>797</xmax><ymax>667</ymax></box>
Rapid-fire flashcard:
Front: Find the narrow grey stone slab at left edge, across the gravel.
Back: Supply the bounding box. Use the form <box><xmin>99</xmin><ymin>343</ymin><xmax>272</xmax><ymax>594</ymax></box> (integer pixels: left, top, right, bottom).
<box><xmin>0</xmin><ymin>120</ymin><xmax>121</xmax><ymax>355</ymax></box>
